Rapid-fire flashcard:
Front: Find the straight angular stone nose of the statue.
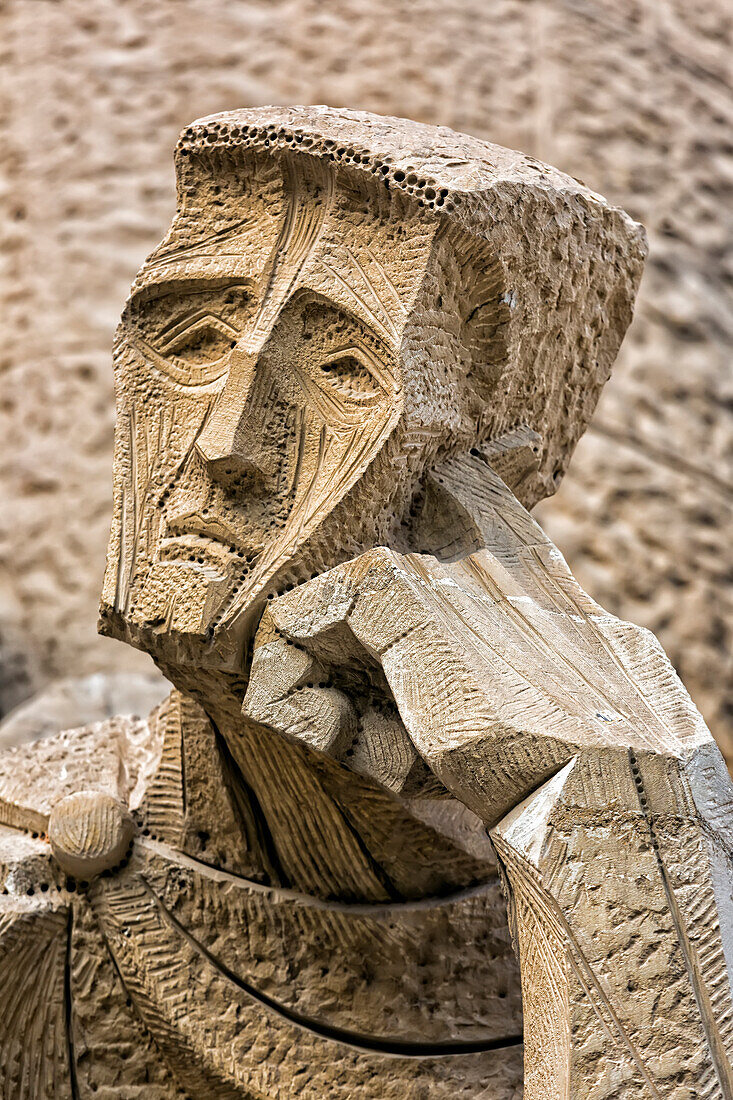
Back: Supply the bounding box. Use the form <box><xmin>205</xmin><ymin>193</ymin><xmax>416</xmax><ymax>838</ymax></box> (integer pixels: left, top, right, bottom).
<box><xmin>196</xmin><ymin>348</ymin><xmax>267</xmax><ymax>480</ymax></box>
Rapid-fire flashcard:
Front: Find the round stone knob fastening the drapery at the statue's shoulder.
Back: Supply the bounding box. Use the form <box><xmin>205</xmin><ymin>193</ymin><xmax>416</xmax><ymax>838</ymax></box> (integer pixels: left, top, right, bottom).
<box><xmin>48</xmin><ymin>791</ymin><xmax>135</xmax><ymax>880</ymax></box>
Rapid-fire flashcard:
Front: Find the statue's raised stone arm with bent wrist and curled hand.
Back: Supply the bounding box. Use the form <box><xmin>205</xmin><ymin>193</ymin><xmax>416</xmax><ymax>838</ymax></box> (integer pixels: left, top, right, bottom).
<box><xmin>245</xmin><ymin>458</ymin><xmax>733</xmax><ymax>1100</ymax></box>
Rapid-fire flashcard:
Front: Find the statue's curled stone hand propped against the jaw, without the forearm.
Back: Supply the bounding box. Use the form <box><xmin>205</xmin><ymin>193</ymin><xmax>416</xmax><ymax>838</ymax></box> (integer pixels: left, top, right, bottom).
<box><xmin>244</xmin><ymin>460</ymin><xmax>712</xmax><ymax>824</ymax></box>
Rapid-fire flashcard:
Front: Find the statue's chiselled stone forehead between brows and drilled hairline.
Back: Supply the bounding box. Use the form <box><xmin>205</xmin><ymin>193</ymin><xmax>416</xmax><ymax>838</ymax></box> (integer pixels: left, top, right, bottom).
<box><xmin>133</xmin><ymin>154</ymin><xmax>437</xmax><ymax>345</ymax></box>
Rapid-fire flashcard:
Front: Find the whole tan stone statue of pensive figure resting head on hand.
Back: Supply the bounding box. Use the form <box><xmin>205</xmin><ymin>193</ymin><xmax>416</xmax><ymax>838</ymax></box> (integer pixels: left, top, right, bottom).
<box><xmin>0</xmin><ymin>108</ymin><xmax>733</xmax><ymax>1100</ymax></box>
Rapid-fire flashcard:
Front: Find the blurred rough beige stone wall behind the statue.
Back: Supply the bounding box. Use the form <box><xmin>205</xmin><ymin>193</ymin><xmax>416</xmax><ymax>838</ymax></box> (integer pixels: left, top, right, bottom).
<box><xmin>0</xmin><ymin>0</ymin><xmax>733</xmax><ymax>757</ymax></box>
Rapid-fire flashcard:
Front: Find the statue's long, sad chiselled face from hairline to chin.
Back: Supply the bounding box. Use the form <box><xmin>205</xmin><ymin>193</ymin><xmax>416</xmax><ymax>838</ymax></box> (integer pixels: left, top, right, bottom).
<box><xmin>102</xmin><ymin>149</ymin><xmax>442</xmax><ymax>667</ymax></box>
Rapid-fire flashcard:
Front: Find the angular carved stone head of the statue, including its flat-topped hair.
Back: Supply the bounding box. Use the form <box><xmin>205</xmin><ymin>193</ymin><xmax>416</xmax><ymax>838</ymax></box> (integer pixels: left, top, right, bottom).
<box><xmin>101</xmin><ymin>108</ymin><xmax>644</xmax><ymax>671</ymax></box>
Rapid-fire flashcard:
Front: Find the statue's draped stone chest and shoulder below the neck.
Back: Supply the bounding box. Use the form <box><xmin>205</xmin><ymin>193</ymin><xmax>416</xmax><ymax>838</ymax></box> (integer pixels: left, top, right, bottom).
<box><xmin>0</xmin><ymin>692</ymin><xmax>522</xmax><ymax>1100</ymax></box>
